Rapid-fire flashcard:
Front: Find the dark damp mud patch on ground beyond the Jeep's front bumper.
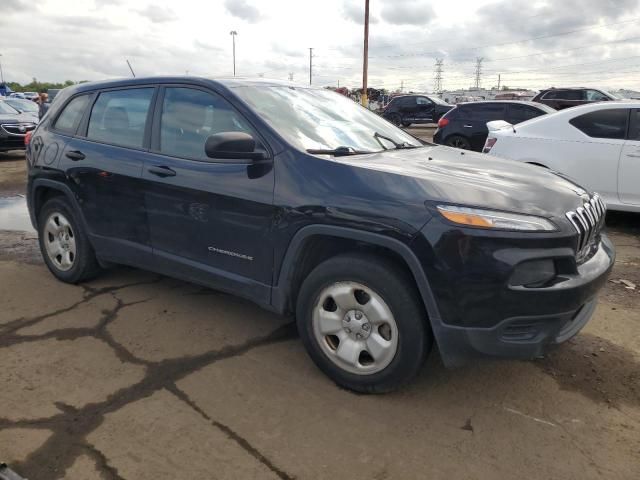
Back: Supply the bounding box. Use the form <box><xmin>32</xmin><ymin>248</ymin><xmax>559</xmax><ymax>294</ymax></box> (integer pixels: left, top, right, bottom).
<box><xmin>535</xmin><ymin>333</ymin><xmax>640</xmax><ymax>406</ymax></box>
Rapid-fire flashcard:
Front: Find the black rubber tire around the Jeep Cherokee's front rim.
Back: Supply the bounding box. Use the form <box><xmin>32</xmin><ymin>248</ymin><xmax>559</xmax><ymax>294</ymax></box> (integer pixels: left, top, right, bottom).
<box><xmin>296</xmin><ymin>253</ymin><xmax>432</xmax><ymax>393</ymax></box>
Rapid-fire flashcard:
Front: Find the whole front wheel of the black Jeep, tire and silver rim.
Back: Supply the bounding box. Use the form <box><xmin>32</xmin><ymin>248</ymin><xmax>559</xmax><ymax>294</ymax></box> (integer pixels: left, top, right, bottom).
<box><xmin>296</xmin><ymin>254</ymin><xmax>431</xmax><ymax>393</ymax></box>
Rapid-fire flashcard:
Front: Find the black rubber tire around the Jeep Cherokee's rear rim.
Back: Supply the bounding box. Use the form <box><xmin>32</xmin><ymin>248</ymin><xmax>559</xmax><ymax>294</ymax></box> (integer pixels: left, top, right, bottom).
<box><xmin>38</xmin><ymin>197</ymin><xmax>100</xmax><ymax>283</ymax></box>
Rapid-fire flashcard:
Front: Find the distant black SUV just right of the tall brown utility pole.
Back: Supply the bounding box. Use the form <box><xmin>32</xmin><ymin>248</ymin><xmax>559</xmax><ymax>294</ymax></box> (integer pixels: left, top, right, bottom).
<box><xmin>382</xmin><ymin>95</ymin><xmax>453</xmax><ymax>127</ymax></box>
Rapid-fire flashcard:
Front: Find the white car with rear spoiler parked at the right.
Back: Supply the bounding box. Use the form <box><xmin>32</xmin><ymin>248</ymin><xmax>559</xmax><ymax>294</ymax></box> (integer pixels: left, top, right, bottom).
<box><xmin>483</xmin><ymin>101</ymin><xmax>640</xmax><ymax>212</ymax></box>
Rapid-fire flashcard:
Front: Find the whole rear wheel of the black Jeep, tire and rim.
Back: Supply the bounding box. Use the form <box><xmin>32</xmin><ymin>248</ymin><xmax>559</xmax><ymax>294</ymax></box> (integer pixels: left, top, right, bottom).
<box><xmin>38</xmin><ymin>197</ymin><xmax>100</xmax><ymax>283</ymax></box>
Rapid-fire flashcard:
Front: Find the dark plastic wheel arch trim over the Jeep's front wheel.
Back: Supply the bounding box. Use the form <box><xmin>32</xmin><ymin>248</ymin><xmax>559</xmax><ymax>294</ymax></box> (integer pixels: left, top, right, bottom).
<box><xmin>271</xmin><ymin>225</ymin><xmax>440</xmax><ymax>325</ymax></box>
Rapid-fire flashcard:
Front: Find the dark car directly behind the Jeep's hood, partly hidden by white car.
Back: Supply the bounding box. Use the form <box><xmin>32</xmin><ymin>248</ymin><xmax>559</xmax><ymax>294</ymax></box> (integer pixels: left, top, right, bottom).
<box><xmin>433</xmin><ymin>100</ymin><xmax>555</xmax><ymax>152</ymax></box>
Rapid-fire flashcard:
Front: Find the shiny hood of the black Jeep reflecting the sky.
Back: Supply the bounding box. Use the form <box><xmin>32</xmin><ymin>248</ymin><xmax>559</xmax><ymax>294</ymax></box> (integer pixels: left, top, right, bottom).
<box><xmin>337</xmin><ymin>146</ymin><xmax>587</xmax><ymax>217</ymax></box>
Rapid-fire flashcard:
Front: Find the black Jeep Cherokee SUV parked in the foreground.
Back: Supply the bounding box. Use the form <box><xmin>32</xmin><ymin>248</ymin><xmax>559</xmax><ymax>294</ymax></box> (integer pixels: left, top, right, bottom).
<box><xmin>27</xmin><ymin>77</ymin><xmax>614</xmax><ymax>392</ymax></box>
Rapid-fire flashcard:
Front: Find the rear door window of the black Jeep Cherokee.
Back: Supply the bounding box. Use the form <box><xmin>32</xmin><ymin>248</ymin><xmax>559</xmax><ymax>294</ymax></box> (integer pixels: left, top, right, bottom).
<box><xmin>87</xmin><ymin>87</ymin><xmax>154</xmax><ymax>148</ymax></box>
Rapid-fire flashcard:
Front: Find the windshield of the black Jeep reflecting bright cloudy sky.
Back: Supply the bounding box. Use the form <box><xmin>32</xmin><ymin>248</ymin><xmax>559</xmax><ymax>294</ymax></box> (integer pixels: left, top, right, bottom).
<box><xmin>234</xmin><ymin>86</ymin><xmax>422</xmax><ymax>152</ymax></box>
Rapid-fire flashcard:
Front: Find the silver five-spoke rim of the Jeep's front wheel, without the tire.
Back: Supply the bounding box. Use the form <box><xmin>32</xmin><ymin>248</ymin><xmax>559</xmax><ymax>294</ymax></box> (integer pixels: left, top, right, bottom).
<box><xmin>312</xmin><ymin>282</ymin><xmax>398</xmax><ymax>375</ymax></box>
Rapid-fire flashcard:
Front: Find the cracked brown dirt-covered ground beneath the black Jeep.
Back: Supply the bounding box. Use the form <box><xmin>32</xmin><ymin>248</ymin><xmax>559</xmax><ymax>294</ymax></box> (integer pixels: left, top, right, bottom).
<box><xmin>0</xmin><ymin>149</ymin><xmax>640</xmax><ymax>480</ymax></box>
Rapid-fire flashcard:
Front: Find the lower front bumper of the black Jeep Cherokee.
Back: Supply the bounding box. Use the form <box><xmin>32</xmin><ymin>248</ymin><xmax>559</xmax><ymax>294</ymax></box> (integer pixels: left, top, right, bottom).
<box><xmin>416</xmin><ymin>227</ymin><xmax>615</xmax><ymax>366</ymax></box>
